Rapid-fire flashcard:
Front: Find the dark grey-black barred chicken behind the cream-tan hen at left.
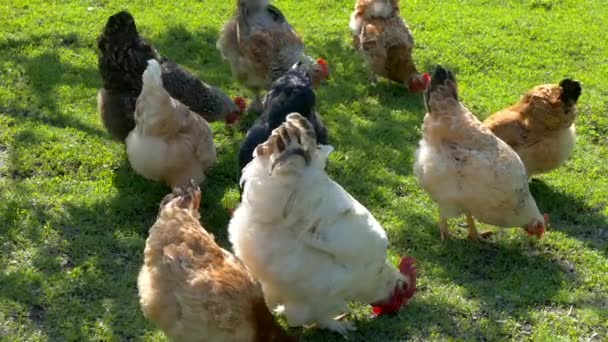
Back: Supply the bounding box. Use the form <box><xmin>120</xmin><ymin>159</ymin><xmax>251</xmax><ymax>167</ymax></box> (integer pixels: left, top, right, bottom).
<box><xmin>97</xmin><ymin>11</ymin><xmax>245</xmax><ymax>141</ymax></box>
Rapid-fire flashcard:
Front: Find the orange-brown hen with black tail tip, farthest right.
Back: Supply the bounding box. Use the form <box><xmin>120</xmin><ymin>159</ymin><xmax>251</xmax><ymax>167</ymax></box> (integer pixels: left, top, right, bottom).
<box><xmin>484</xmin><ymin>79</ymin><xmax>581</xmax><ymax>177</ymax></box>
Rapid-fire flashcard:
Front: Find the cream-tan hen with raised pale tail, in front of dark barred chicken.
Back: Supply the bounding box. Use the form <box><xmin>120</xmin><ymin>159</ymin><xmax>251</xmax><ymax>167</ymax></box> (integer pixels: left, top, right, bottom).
<box><xmin>125</xmin><ymin>60</ymin><xmax>216</xmax><ymax>188</ymax></box>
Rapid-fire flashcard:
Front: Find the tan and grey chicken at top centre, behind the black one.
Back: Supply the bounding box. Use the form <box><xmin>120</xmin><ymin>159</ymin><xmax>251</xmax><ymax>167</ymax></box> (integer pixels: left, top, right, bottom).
<box><xmin>217</xmin><ymin>0</ymin><xmax>329</xmax><ymax>111</ymax></box>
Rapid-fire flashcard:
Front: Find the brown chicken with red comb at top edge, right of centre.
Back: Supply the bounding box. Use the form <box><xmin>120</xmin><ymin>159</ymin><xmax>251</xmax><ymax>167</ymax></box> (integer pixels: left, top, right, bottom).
<box><xmin>349</xmin><ymin>0</ymin><xmax>430</xmax><ymax>92</ymax></box>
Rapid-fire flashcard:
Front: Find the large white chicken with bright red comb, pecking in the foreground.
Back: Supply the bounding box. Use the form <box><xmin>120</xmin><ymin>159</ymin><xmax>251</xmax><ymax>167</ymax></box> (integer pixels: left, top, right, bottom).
<box><xmin>228</xmin><ymin>113</ymin><xmax>416</xmax><ymax>335</ymax></box>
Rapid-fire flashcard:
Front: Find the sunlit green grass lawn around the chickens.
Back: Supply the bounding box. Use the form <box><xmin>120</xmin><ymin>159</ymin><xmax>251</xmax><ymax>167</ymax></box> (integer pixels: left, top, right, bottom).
<box><xmin>0</xmin><ymin>0</ymin><xmax>608</xmax><ymax>341</ymax></box>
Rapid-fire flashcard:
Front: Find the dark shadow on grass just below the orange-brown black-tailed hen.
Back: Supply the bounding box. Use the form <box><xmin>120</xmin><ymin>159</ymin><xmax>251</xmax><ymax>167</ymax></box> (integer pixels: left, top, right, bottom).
<box><xmin>530</xmin><ymin>178</ymin><xmax>608</xmax><ymax>256</ymax></box>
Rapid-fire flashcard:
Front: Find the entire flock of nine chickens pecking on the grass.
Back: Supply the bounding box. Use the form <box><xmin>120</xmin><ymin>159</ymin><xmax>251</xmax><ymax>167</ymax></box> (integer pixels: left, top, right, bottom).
<box><xmin>92</xmin><ymin>0</ymin><xmax>581</xmax><ymax>341</ymax></box>
